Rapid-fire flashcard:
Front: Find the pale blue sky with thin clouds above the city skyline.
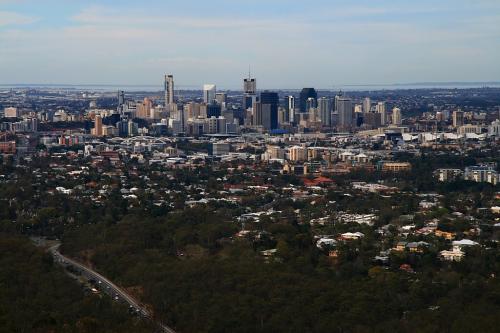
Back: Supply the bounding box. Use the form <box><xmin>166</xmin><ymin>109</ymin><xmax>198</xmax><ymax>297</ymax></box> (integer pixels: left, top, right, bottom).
<box><xmin>0</xmin><ymin>0</ymin><xmax>500</xmax><ymax>89</ymax></box>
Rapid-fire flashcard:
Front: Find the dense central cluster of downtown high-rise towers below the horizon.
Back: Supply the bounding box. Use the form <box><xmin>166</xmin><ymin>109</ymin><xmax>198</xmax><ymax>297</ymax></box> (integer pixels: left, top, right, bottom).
<box><xmin>84</xmin><ymin>75</ymin><xmax>452</xmax><ymax>136</ymax></box>
